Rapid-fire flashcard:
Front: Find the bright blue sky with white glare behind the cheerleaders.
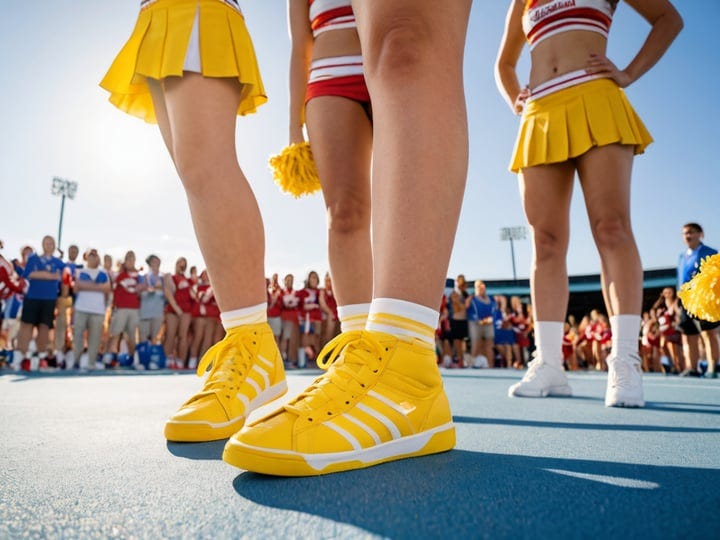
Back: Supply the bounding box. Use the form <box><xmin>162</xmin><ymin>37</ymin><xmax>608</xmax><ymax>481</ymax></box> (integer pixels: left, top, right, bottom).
<box><xmin>0</xmin><ymin>0</ymin><xmax>720</xmax><ymax>279</ymax></box>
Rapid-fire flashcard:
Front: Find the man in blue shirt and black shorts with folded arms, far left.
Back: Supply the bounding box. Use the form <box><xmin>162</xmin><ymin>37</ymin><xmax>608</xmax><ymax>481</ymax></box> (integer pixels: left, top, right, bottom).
<box><xmin>14</xmin><ymin>236</ymin><xmax>65</xmax><ymax>371</ymax></box>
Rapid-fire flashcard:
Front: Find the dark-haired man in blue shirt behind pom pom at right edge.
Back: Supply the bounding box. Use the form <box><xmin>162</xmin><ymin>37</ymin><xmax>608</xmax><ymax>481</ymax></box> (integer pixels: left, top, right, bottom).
<box><xmin>677</xmin><ymin>223</ymin><xmax>720</xmax><ymax>378</ymax></box>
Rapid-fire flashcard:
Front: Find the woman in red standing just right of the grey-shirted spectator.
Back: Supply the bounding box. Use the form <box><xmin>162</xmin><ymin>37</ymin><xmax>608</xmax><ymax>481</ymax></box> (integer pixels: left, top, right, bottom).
<box><xmin>163</xmin><ymin>257</ymin><xmax>193</xmax><ymax>369</ymax></box>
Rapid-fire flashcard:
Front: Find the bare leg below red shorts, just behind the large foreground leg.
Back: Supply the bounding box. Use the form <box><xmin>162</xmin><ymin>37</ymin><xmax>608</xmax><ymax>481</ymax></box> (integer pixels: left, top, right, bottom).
<box><xmin>307</xmin><ymin>96</ymin><xmax>373</xmax><ymax>305</ymax></box>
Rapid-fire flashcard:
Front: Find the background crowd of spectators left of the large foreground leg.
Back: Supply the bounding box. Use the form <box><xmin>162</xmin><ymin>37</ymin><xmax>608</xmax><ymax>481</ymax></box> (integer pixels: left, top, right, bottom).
<box><xmin>0</xmin><ymin>236</ymin><xmax>339</xmax><ymax>371</ymax></box>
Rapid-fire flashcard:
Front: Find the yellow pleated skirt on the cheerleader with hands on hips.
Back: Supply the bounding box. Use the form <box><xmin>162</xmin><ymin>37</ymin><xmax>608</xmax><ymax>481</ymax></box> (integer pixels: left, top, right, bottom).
<box><xmin>510</xmin><ymin>79</ymin><xmax>653</xmax><ymax>173</ymax></box>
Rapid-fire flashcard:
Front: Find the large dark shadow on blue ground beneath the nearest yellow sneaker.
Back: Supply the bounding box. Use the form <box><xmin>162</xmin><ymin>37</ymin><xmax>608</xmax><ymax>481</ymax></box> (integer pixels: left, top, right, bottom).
<box><xmin>233</xmin><ymin>449</ymin><xmax>720</xmax><ymax>538</ymax></box>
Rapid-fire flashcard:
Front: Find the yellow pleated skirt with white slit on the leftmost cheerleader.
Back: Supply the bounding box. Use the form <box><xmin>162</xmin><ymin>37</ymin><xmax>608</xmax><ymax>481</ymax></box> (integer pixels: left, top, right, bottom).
<box><xmin>100</xmin><ymin>0</ymin><xmax>267</xmax><ymax>123</ymax></box>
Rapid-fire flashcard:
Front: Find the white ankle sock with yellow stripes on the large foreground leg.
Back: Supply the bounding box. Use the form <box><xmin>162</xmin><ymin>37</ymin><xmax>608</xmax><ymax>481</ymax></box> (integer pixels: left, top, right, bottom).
<box><xmin>365</xmin><ymin>298</ymin><xmax>440</xmax><ymax>345</ymax></box>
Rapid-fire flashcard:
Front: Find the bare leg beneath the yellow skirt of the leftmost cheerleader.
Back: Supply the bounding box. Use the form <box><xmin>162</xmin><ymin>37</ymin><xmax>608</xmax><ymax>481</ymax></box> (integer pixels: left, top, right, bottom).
<box><xmin>153</xmin><ymin>73</ymin><xmax>266</xmax><ymax>311</ymax></box>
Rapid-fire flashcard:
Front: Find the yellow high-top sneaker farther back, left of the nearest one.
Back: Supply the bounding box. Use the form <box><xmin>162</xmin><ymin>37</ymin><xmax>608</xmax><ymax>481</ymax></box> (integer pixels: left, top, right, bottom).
<box><xmin>165</xmin><ymin>323</ymin><xmax>287</xmax><ymax>442</ymax></box>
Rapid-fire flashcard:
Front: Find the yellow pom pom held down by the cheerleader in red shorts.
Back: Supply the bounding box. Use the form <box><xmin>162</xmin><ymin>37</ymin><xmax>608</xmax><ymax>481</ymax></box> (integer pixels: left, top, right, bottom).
<box><xmin>270</xmin><ymin>142</ymin><xmax>320</xmax><ymax>198</ymax></box>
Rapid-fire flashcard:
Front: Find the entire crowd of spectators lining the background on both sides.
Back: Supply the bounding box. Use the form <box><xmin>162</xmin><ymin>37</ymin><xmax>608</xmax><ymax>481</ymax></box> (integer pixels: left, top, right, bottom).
<box><xmin>0</xmin><ymin>236</ymin><xmax>717</xmax><ymax>376</ymax></box>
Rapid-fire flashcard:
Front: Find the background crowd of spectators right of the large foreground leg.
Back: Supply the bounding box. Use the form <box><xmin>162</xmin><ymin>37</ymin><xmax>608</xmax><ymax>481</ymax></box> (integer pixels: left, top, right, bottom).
<box><xmin>436</xmin><ymin>275</ymin><xmax>718</xmax><ymax>376</ymax></box>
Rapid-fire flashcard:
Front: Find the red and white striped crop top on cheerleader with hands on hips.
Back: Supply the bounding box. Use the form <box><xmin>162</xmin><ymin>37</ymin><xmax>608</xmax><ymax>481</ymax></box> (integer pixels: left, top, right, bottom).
<box><xmin>522</xmin><ymin>0</ymin><xmax>615</xmax><ymax>50</ymax></box>
